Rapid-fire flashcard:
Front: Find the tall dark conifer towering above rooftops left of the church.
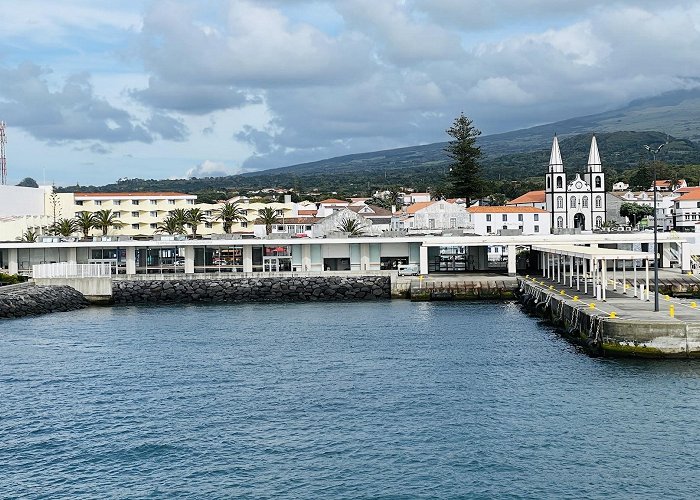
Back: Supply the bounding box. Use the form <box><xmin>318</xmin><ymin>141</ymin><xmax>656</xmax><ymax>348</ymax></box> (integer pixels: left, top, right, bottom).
<box><xmin>445</xmin><ymin>113</ymin><xmax>483</xmax><ymax>206</ymax></box>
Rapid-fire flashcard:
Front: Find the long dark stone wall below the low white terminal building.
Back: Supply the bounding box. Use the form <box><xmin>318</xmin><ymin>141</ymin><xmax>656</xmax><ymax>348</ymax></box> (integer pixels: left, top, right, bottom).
<box><xmin>112</xmin><ymin>276</ymin><xmax>391</xmax><ymax>304</ymax></box>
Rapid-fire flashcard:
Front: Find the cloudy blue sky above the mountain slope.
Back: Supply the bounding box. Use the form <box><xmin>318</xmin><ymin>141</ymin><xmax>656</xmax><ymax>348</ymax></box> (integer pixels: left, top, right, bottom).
<box><xmin>0</xmin><ymin>0</ymin><xmax>700</xmax><ymax>186</ymax></box>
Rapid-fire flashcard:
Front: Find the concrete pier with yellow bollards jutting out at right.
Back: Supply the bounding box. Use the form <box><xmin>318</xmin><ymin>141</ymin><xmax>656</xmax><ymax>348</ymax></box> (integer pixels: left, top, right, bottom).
<box><xmin>518</xmin><ymin>276</ymin><xmax>700</xmax><ymax>358</ymax></box>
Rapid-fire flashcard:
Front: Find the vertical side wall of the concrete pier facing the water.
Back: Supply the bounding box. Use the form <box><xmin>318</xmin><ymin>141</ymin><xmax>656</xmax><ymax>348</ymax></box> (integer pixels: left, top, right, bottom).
<box><xmin>518</xmin><ymin>279</ymin><xmax>700</xmax><ymax>358</ymax></box>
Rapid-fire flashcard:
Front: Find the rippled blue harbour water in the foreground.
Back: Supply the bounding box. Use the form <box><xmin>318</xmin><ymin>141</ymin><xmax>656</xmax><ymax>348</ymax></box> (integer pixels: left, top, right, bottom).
<box><xmin>0</xmin><ymin>301</ymin><xmax>700</xmax><ymax>499</ymax></box>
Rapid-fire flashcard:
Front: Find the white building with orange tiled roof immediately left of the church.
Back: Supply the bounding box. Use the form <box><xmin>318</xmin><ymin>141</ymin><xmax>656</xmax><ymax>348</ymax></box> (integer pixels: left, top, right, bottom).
<box><xmin>467</xmin><ymin>206</ymin><xmax>550</xmax><ymax>235</ymax></box>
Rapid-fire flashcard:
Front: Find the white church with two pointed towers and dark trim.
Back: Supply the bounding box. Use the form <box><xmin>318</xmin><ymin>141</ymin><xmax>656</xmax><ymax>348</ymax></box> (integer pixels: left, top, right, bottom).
<box><xmin>545</xmin><ymin>136</ymin><xmax>606</xmax><ymax>233</ymax></box>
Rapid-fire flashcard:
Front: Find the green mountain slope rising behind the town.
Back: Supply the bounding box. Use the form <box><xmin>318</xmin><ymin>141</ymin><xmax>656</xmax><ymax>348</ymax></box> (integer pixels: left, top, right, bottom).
<box><xmin>58</xmin><ymin>89</ymin><xmax>700</xmax><ymax>194</ymax></box>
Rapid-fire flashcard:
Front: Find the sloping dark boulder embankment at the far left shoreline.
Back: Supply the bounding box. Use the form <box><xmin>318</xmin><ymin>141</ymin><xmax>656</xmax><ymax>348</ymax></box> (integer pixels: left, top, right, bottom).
<box><xmin>0</xmin><ymin>286</ymin><xmax>88</xmax><ymax>318</ymax></box>
